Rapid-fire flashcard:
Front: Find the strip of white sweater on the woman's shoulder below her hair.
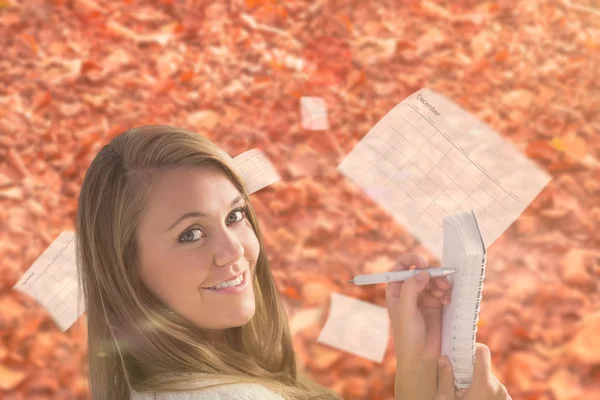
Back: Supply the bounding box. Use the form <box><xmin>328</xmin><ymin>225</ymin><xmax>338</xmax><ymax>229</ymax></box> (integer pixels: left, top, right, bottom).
<box><xmin>131</xmin><ymin>383</ymin><xmax>285</xmax><ymax>400</ymax></box>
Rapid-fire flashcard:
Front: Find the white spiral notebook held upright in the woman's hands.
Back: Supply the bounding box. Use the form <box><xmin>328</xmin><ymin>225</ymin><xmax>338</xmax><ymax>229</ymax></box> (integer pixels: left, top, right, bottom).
<box><xmin>441</xmin><ymin>211</ymin><xmax>486</xmax><ymax>389</ymax></box>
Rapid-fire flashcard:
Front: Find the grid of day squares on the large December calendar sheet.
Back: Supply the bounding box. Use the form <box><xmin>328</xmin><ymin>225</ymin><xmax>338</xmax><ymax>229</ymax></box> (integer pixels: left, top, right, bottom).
<box><xmin>354</xmin><ymin>104</ymin><xmax>517</xmax><ymax>244</ymax></box>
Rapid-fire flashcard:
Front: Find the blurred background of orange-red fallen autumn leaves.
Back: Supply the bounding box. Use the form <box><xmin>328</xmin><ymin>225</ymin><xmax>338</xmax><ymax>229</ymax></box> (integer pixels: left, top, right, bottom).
<box><xmin>0</xmin><ymin>0</ymin><xmax>600</xmax><ymax>400</ymax></box>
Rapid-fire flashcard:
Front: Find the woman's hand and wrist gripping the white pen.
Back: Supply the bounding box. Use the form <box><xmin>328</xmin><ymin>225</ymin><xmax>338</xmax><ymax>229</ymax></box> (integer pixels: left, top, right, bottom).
<box><xmin>386</xmin><ymin>254</ymin><xmax>451</xmax><ymax>400</ymax></box>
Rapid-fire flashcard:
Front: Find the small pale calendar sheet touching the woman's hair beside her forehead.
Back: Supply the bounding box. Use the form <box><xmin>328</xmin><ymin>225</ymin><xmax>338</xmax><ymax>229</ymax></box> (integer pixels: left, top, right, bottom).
<box><xmin>233</xmin><ymin>149</ymin><xmax>281</xmax><ymax>194</ymax></box>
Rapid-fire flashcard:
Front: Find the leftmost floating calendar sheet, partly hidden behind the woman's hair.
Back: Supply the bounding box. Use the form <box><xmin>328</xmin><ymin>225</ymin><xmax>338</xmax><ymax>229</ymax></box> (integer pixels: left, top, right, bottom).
<box><xmin>14</xmin><ymin>231</ymin><xmax>85</xmax><ymax>332</ymax></box>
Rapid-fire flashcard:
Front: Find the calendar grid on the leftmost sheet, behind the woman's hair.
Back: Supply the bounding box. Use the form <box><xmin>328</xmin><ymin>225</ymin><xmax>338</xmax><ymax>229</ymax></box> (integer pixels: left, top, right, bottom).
<box><xmin>30</xmin><ymin>242</ymin><xmax>78</xmax><ymax>315</ymax></box>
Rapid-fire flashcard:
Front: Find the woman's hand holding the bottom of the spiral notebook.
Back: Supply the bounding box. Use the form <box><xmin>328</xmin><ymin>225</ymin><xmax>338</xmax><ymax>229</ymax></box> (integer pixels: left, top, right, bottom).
<box><xmin>435</xmin><ymin>343</ymin><xmax>512</xmax><ymax>400</ymax></box>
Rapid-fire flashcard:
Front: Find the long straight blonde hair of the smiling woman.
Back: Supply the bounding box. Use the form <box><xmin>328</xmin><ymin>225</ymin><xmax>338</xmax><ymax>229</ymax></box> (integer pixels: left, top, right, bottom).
<box><xmin>76</xmin><ymin>125</ymin><xmax>339</xmax><ymax>400</ymax></box>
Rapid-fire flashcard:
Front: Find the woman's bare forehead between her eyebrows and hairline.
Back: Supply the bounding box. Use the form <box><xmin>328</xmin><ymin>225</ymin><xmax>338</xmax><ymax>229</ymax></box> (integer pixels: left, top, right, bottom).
<box><xmin>147</xmin><ymin>167</ymin><xmax>240</xmax><ymax>221</ymax></box>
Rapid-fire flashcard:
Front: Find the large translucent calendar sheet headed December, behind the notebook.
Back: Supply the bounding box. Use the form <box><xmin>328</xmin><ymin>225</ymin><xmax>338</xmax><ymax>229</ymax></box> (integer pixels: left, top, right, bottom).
<box><xmin>338</xmin><ymin>89</ymin><xmax>551</xmax><ymax>259</ymax></box>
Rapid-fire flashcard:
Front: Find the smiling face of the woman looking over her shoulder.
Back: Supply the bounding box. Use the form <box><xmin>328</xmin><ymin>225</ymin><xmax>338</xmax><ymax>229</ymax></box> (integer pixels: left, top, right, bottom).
<box><xmin>137</xmin><ymin>167</ymin><xmax>260</xmax><ymax>330</ymax></box>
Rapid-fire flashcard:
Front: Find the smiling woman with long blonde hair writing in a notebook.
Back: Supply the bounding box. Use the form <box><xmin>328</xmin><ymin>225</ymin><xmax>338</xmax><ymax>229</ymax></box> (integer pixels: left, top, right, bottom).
<box><xmin>72</xmin><ymin>126</ymin><xmax>508</xmax><ymax>400</ymax></box>
